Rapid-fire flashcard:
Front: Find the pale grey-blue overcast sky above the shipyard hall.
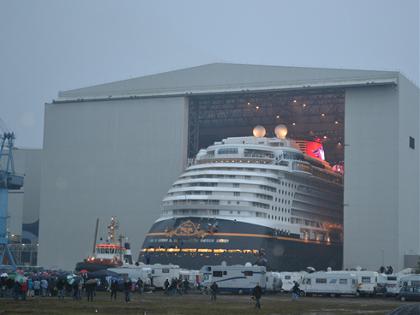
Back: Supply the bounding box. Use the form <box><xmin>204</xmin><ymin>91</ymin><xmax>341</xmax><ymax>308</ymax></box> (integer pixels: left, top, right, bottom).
<box><xmin>0</xmin><ymin>0</ymin><xmax>420</xmax><ymax>147</ymax></box>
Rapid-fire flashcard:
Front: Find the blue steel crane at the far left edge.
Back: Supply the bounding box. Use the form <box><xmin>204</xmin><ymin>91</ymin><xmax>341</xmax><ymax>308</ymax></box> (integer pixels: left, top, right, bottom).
<box><xmin>0</xmin><ymin>119</ymin><xmax>23</xmax><ymax>270</ymax></box>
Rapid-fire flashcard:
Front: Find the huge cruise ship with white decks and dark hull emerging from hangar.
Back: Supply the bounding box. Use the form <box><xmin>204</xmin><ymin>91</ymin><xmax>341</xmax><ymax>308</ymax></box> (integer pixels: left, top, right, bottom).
<box><xmin>139</xmin><ymin>125</ymin><xmax>343</xmax><ymax>271</ymax></box>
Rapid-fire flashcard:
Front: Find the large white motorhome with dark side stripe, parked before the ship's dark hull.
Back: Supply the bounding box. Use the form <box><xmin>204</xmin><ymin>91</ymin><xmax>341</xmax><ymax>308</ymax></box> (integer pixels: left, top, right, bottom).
<box><xmin>200</xmin><ymin>264</ymin><xmax>266</xmax><ymax>294</ymax></box>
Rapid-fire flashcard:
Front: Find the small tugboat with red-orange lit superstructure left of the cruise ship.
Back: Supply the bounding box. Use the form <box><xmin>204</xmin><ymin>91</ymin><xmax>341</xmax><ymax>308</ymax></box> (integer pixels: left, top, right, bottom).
<box><xmin>75</xmin><ymin>217</ymin><xmax>133</xmax><ymax>272</ymax></box>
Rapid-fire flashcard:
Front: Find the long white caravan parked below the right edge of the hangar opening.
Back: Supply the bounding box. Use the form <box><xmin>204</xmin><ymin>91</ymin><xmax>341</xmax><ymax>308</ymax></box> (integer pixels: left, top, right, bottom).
<box><xmin>300</xmin><ymin>271</ymin><xmax>357</xmax><ymax>296</ymax></box>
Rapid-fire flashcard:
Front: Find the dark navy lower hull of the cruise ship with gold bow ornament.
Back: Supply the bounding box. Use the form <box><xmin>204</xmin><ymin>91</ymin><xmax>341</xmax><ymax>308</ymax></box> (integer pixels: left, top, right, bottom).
<box><xmin>139</xmin><ymin>217</ymin><xmax>343</xmax><ymax>271</ymax></box>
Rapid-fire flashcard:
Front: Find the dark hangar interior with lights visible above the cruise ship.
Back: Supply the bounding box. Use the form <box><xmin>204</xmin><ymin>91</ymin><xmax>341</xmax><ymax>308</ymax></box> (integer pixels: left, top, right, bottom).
<box><xmin>188</xmin><ymin>89</ymin><xmax>345</xmax><ymax>165</ymax></box>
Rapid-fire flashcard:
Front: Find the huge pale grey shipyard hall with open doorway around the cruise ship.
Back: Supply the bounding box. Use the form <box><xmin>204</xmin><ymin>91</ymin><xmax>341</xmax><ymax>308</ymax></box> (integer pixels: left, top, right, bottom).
<box><xmin>38</xmin><ymin>63</ymin><xmax>420</xmax><ymax>269</ymax></box>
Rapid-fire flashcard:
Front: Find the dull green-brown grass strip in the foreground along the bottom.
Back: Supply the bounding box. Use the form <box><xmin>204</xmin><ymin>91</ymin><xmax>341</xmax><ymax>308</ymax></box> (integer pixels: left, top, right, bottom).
<box><xmin>0</xmin><ymin>293</ymin><xmax>408</xmax><ymax>315</ymax></box>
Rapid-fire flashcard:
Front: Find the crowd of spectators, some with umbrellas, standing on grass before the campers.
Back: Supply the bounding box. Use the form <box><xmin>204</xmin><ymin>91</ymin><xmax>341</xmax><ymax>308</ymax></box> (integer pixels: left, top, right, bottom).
<box><xmin>0</xmin><ymin>271</ymin><xmax>300</xmax><ymax>308</ymax></box>
